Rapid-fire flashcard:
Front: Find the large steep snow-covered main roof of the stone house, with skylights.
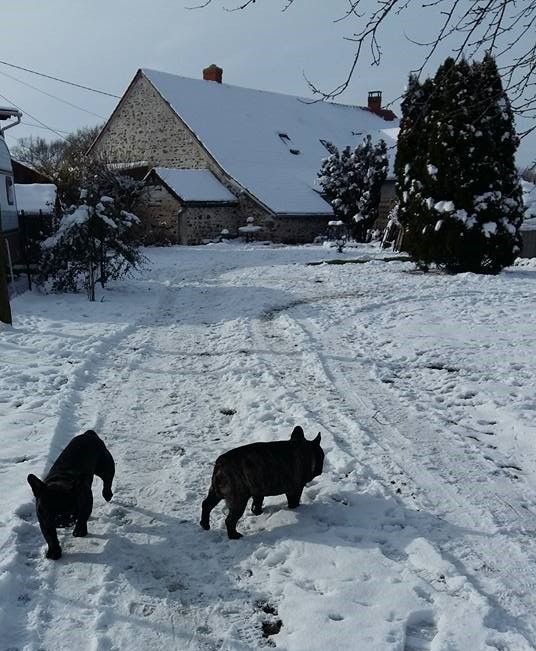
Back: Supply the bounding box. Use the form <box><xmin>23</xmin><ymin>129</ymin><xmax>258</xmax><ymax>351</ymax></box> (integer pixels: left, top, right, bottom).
<box><xmin>141</xmin><ymin>69</ymin><xmax>398</xmax><ymax>215</ymax></box>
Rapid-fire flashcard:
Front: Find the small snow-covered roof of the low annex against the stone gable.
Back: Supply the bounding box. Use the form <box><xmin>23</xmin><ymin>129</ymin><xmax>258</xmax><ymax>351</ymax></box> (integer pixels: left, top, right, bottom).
<box><xmin>150</xmin><ymin>167</ymin><xmax>237</xmax><ymax>203</ymax></box>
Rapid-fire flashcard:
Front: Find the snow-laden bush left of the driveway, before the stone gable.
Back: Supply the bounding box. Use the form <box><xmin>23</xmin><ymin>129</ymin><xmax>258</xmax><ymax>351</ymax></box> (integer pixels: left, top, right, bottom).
<box><xmin>37</xmin><ymin>168</ymin><xmax>144</xmax><ymax>301</ymax></box>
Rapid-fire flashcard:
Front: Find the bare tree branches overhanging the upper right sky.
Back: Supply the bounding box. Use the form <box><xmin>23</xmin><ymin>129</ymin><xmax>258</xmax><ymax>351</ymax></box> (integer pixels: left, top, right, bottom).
<box><xmin>192</xmin><ymin>0</ymin><xmax>536</xmax><ymax>136</ymax></box>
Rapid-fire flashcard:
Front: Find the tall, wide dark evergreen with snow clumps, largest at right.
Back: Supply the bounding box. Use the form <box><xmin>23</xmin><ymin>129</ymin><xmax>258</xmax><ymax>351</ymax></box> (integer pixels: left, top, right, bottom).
<box><xmin>396</xmin><ymin>55</ymin><xmax>523</xmax><ymax>273</ymax></box>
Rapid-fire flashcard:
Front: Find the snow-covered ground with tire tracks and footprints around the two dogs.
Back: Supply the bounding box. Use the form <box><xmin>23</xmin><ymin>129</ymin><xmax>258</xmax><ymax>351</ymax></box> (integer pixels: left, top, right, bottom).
<box><xmin>0</xmin><ymin>244</ymin><xmax>536</xmax><ymax>651</ymax></box>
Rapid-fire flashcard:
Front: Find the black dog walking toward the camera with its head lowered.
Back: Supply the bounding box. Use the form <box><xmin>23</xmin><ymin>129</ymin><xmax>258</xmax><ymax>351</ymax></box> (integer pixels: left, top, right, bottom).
<box><xmin>28</xmin><ymin>430</ymin><xmax>115</xmax><ymax>560</ymax></box>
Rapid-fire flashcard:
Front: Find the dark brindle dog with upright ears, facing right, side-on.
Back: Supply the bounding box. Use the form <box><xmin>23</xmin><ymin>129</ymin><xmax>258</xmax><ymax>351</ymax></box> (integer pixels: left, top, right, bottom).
<box><xmin>201</xmin><ymin>426</ymin><xmax>324</xmax><ymax>539</ymax></box>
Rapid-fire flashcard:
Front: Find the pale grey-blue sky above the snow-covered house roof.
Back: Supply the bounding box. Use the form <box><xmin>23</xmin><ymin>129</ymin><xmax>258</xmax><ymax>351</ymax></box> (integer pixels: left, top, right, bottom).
<box><xmin>0</xmin><ymin>0</ymin><xmax>536</xmax><ymax>167</ymax></box>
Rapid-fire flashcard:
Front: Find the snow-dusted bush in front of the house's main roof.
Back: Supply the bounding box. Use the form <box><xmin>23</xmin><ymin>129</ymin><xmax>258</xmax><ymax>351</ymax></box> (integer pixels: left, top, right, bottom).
<box><xmin>318</xmin><ymin>136</ymin><xmax>389</xmax><ymax>242</ymax></box>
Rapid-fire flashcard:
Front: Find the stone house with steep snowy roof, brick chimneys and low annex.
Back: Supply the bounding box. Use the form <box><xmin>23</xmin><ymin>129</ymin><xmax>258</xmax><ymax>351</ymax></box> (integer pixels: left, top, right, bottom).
<box><xmin>90</xmin><ymin>65</ymin><xmax>398</xmax><ymax>244</ymax></box>
